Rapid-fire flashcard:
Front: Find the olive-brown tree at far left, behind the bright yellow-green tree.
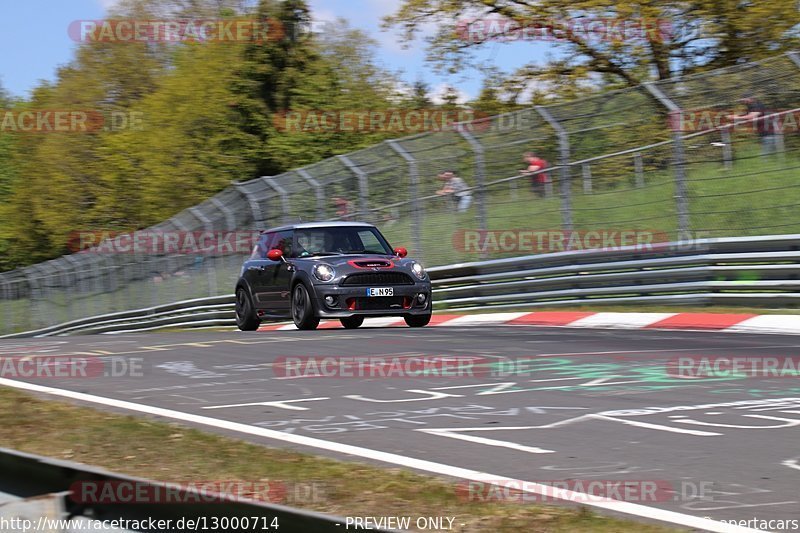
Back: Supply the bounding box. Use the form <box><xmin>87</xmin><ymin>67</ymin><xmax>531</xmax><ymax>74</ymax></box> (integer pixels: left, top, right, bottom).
<box><xmin>0</xmin><ymin>1</ymin><xmax>166</xmax><ymax>262</ymax></box>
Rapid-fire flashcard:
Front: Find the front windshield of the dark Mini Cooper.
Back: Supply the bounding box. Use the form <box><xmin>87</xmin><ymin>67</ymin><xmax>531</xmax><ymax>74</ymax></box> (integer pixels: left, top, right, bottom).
<box><xmin>295</xmin><ymin>226</ymin><xmax>392</xmax><ymax>257</ymax></box>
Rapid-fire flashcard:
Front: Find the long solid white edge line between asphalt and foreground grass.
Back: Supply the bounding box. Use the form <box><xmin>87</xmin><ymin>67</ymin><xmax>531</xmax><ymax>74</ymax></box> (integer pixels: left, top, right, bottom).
<box><xmin>0</xmin><ymin>378</ymin><xmax>765</xmax><ymax>533</ymax></box>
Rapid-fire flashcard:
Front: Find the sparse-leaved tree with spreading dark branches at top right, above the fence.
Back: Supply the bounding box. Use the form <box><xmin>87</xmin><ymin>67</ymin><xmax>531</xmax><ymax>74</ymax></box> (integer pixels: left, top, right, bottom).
<box><xmin>385</xmin><ymin>0</ymin><xmax>800</xmax><ymax>86</ymax></box>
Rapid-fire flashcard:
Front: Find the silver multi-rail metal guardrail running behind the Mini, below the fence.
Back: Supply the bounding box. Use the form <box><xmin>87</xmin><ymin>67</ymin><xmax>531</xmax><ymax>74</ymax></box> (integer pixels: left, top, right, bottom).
<box><xmin>0</xmin><ymin>235</ymin><xmax>800</xmax><ymax>338</ymax></box>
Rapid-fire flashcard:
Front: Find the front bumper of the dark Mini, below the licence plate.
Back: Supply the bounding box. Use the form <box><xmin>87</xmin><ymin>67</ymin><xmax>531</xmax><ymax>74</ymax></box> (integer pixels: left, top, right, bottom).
<box><xmin>311</xmin><ymin>281</ymin><xmax>432</xmax><ymax>318</ymax></box>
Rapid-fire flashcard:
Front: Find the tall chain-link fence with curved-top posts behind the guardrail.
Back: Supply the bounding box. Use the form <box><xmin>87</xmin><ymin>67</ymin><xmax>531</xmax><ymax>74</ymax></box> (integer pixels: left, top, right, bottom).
<box><xmin>0</xmin><ymin>53</ymin><xmax>800</xmax><ymax>334</ymax></box>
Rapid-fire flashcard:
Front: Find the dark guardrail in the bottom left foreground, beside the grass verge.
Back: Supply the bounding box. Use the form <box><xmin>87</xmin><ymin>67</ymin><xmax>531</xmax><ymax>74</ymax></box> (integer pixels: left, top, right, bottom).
<box><xmin>0</xmin><ymin>448</ymin><xmax>386</xmax><ymax>533</ymax></box>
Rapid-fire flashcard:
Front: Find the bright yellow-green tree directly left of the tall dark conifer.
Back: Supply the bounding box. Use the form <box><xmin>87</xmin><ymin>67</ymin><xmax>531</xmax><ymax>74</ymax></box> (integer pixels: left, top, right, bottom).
<box><xmin>95</xmin><ymin>35</ymin><xmax>261</xmax><ymax>223</ymax></box>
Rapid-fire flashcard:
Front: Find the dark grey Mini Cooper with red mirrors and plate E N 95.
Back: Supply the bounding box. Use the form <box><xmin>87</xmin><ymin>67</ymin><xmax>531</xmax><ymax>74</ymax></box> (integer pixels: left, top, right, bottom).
<box><xmin>236</xmin><ymin>222</ymin><xmax>431</xmax><ymax>331</ymax></box>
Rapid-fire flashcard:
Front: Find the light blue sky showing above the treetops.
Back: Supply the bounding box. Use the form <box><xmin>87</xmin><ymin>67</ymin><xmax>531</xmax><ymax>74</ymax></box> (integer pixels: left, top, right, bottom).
<box><xmin>0</xmin><ymin>0</ymin><xmax>549</xmax><ymax>99</ymax></box>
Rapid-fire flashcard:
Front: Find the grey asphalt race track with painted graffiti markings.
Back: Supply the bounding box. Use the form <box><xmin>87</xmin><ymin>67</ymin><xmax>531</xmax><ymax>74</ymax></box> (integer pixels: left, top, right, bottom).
<box><xmin>0</xmin><ymin>326</ymin><xmax>800</xmax><ymax>531</ymax></box>
